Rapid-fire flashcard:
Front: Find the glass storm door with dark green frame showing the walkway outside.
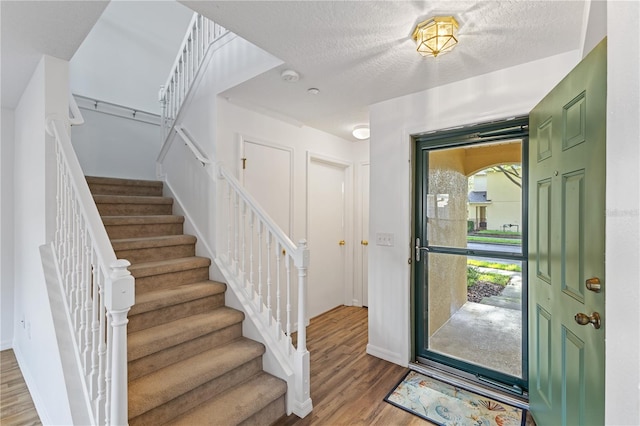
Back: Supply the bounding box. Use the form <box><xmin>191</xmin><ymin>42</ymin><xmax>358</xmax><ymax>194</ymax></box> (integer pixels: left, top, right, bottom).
<box><xmin>414</xmin><ymin>138</ymin><xmax>526</xmax><ymax>389</ymax></box>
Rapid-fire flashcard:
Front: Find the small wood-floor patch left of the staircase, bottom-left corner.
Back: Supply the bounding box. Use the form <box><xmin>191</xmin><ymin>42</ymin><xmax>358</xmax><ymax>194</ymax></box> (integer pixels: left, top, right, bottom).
<box><xmin>0</xmin><ymin>349</ymin><xmax>42</xmax><ymax>426</ymax></box>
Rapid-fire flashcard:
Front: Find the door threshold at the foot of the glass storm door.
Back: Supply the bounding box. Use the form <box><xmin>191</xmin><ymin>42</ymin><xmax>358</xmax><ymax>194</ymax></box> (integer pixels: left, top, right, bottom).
<box><xmin>409</xmin><ymin>362</ymin><xmax>529</xmax><ymax>410</ymax></box>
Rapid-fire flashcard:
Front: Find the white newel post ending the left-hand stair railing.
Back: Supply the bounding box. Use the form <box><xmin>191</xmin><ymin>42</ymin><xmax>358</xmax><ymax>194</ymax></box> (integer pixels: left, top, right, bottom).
<box><xmin>106</xmin><ymin>259</ymin><xmax>135</xmax><ymax>425</ymax></box>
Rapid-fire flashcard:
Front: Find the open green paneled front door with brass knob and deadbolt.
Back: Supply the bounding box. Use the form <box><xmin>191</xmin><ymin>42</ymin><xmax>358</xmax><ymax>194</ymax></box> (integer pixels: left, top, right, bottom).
<box><xmin>529</xmin><ymin>40</ymin><xmax>608</xmax><ymax>425</ymax></box>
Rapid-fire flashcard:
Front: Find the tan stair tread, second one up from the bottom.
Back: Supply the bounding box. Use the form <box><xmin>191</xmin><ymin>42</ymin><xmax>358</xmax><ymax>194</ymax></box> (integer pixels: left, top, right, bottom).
<box><xmin>129</xmin><ymin>337</ymin><xmax>264</xmax><ymax>417</ymax></box>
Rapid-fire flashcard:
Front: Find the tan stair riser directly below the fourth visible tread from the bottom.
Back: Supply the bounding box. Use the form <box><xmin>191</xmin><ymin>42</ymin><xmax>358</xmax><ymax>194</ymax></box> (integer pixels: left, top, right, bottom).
<box><xmin>127</xmin><ymin>293</ymin><xmax>224</xmax><ymax>333</ymax></box>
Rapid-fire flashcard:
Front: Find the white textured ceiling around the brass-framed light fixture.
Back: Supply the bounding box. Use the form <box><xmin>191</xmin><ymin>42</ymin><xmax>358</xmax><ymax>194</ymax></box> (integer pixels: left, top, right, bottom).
<box><xmin>181</xmin><ymin>0</ymin><xmax>586</xmax><ymax>140</ymax></box>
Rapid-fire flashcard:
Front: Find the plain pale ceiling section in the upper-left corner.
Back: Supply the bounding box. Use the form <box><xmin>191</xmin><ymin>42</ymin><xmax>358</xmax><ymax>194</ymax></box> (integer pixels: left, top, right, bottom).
<box><xmin>0</xmin><ymin>0</ymin><xmax>109</xmax><ymax>108</ymax></box>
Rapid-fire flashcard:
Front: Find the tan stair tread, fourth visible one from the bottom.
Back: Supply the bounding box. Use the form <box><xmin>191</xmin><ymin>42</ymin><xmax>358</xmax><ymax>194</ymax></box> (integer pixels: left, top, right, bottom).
<box><xmin>129</xmin><ymin>281</ymin><xmax>227</xmax><ymax>316</ymax></box>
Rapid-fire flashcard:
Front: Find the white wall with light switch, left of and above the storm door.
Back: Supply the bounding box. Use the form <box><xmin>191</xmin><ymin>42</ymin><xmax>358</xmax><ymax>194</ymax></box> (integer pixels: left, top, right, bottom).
<box><xmin>367</xmin><ymin>52</ymin><xmax>579</xmax><ymax>365</ymax></box>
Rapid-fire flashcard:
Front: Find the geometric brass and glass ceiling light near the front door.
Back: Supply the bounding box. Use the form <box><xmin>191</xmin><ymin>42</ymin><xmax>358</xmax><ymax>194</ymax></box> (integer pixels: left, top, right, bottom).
<box><xmin>413</xmin><ymin>16</ymin><xmax>458</xmax><ymax>57</ymax></box>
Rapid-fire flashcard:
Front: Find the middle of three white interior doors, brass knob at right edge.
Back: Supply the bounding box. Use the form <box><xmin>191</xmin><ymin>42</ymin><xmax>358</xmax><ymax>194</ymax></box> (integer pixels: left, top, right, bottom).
<box><xmin>307</xmin><ymin>158</ymin><xmax>353</xmax><ymax>318</ymax></box>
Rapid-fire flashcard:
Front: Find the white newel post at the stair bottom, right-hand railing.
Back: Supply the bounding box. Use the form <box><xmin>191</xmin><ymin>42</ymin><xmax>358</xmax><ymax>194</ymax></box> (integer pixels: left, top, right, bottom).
<box><xmin>292</xmin><ymin>239</ymin><xmax>313</xmax><ymax>418</ymax></box>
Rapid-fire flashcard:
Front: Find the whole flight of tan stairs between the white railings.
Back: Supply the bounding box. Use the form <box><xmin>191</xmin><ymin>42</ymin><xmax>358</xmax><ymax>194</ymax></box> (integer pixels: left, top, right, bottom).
<box><xmin>86</xmin><ymin>177</ymin><xmax>287</xmax><ymax>426</ymax></box>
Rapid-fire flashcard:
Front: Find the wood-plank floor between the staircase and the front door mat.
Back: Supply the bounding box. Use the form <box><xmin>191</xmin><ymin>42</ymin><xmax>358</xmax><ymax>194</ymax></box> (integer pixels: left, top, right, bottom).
<box><xmin>275</xmin><ymin>306</ymin><xmax>430</xmax><ymax>426</ymax></box>
